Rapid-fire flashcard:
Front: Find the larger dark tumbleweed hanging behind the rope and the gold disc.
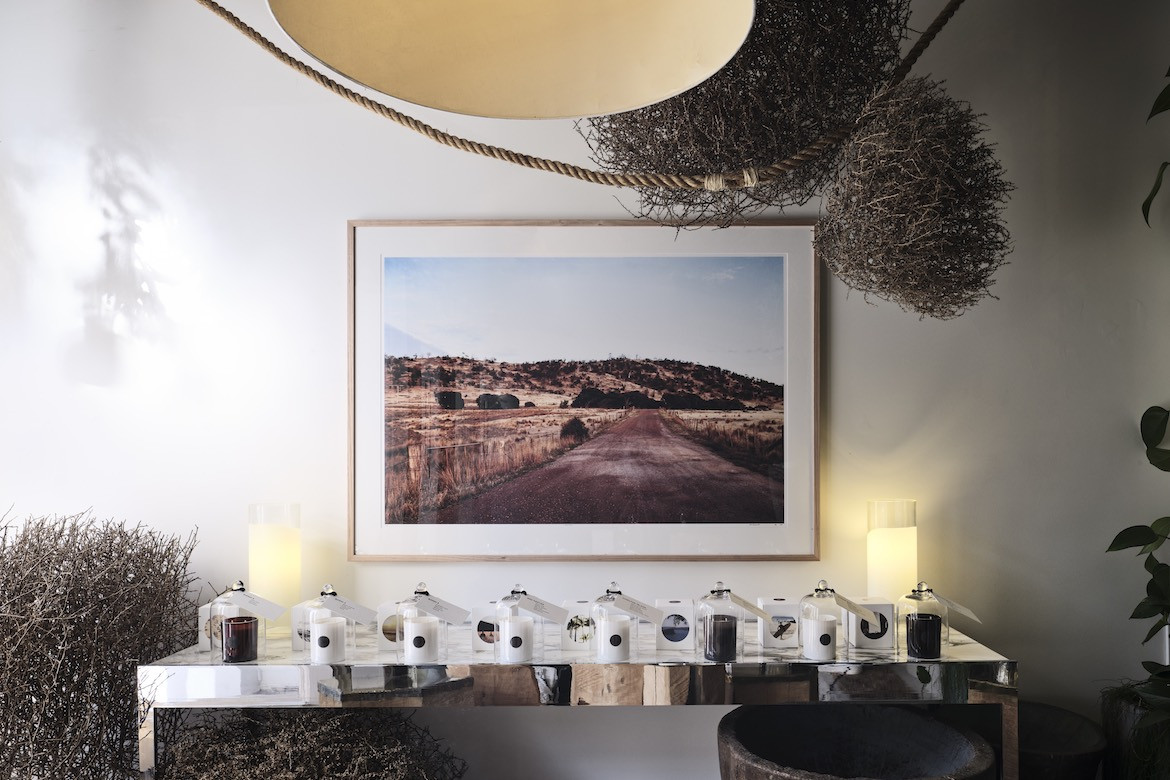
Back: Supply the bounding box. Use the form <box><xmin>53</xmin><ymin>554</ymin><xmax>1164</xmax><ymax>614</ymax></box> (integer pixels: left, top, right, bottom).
<box><xmin>578</xmin><ymin>0</ymin><xmax>909</xmax><ymax>226</ymax></box>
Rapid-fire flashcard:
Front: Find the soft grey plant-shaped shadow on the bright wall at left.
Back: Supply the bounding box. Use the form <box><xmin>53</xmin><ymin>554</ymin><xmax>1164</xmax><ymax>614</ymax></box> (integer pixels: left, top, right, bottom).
<box><xmin>69</xmin><ymin>146</ymin><xmax>170</xmax><ymax>386</ymax></box>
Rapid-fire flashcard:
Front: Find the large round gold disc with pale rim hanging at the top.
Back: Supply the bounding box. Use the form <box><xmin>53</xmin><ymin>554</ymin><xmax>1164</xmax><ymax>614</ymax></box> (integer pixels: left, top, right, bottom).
<box><xmin>269</xmin><ymin>0</ymin><xmax>755</xmax><ymax>119</ymax></box>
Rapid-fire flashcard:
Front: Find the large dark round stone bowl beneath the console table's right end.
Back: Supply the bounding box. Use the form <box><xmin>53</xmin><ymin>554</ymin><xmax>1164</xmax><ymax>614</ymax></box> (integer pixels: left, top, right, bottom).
<box><xmin>718</xmin><ymin>704</ymin><xmax>996</xmax><ymax>780</ymax></box>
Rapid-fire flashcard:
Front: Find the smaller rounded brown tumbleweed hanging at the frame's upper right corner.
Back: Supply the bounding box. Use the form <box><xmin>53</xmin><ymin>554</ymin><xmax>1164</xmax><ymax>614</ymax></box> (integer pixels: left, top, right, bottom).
<box><xmin>817</xmin><ymin>78</ymin><xmax>1012</xmax><ymax>319</ymax></box>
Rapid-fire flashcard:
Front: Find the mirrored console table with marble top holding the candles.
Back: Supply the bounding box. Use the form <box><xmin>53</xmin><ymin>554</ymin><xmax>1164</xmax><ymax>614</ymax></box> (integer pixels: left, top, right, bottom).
<box><xmin>138</xmin><ymin>624</ymin><xmax>1018</xmax><ymax>780</ymax></box>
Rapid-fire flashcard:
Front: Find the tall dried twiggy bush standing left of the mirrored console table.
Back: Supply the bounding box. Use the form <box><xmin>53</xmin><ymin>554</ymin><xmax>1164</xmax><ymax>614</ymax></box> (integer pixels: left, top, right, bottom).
<box><xmin>0</xmin><ymin>513</ymin><xmax>195</xmax><ymax>780</ymax></box>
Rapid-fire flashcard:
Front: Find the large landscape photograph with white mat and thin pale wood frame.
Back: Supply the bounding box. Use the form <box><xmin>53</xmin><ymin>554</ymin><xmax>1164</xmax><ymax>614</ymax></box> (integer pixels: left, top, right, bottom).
<box><xmin>349</xmin><ymin>221</ymin><xmax>818</xmax><ymax>561</ymax></box>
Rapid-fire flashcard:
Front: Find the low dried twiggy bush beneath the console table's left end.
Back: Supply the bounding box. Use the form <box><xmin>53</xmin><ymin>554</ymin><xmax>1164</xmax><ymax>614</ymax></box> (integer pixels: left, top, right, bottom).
<box><xmin>159</xmin><ymin>710</ymin><xmax>467</xmax><ymax>780</ymax></box>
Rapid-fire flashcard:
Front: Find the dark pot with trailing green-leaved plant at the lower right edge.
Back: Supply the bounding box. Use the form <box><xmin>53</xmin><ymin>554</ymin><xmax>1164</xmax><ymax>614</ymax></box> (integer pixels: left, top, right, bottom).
<box><xmin>1101</xmin><ymin>406</ymin><xmax>1170</xmax><ymax>779</ymax></box>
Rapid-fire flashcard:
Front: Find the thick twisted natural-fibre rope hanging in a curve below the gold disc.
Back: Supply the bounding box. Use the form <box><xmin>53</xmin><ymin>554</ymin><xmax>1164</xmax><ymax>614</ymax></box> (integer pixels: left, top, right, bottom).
<box><xmin>197</xmin><ymin>0</ymin><xmax>964</xmax><ymax>191</ymax></box>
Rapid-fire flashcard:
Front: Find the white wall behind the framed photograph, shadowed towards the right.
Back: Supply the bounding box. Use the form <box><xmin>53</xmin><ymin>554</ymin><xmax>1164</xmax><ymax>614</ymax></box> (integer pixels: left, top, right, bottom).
<box><xmin>0</xmin><ymin>0</ymin><xmax>1170</xmax><ymax>779</ymax></box>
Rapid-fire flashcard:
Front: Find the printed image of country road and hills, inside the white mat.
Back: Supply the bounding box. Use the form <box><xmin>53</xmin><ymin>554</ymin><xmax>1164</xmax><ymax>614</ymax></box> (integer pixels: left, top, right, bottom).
<box><xmin>381</xmin><ymin>257</ymin><xmax>786</xmax><ymax>525</ymax></box>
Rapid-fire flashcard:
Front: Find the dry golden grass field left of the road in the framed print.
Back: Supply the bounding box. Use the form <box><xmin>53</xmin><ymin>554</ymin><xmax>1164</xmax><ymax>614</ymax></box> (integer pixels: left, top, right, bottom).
<box><xmin>386</xmin><ymin>388</ymin><xmax>626</xmax><ymax>524</ymax></box>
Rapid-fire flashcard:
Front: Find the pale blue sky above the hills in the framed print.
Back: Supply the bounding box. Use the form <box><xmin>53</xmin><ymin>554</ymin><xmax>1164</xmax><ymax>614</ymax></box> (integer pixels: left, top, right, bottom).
<box><xmin>383</xmin><ymin>257</ymin><xmax>785</xmax><ymax>385</ymax></box>
